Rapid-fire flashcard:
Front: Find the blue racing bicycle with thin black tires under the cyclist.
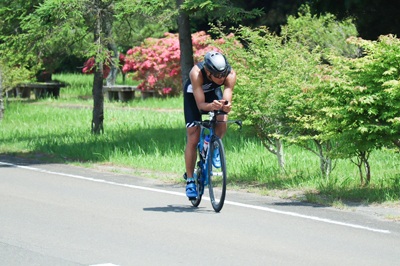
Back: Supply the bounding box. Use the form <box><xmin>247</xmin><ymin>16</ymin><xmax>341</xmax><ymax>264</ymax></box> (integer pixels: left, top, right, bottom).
<box><xmin>190</xmin><ymin>102</ymin><xmax>242</xmax><ymax>212</ymax></box>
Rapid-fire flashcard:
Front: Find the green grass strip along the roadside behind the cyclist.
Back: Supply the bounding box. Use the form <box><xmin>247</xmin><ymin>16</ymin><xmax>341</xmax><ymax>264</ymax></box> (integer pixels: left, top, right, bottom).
<box><xmin>0</xmin><ymin>75</ymin><xmax>400</xmax><ymax>208</ymax></box>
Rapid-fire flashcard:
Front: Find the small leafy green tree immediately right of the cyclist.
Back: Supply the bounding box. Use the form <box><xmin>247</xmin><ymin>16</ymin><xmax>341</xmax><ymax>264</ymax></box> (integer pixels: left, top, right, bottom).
<box><xmin>216</xmin><ymin>27</ymin><xmax>319</xmax><ymax>171</ymax></box>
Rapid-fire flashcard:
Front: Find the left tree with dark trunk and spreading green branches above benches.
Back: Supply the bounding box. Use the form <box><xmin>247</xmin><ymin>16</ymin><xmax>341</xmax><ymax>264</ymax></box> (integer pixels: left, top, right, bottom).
<box><xmin>6</xmin><ymin>0</ymin><xmax>172</xmax><ymax>134</ymax></box>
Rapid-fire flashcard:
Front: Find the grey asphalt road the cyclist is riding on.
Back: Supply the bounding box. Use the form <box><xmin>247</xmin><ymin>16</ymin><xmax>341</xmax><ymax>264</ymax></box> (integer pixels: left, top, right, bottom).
<box><xmin>0</xmin><ymin>156</ymin><xmax>400</xmax><ymax>266</ymax></box>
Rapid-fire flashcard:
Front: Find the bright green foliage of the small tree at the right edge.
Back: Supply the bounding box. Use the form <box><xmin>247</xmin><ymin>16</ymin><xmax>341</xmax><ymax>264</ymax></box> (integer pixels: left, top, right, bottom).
<box><xmin>323</xmin><ymin>35</ymin><xmax>400</xmax><ymax>154</ymax></box>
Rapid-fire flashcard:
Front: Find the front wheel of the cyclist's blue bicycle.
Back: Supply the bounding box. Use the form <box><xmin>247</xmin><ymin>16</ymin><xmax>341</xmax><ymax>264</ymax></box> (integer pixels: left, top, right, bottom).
<box><xmin>208</xmin><ymin>136</ymin><xmax>226</xmax><ymax>212</ymax></box>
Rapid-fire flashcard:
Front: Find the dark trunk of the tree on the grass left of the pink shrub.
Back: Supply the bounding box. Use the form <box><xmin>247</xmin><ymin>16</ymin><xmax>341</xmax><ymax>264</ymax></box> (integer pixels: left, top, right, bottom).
<box><xmin>92</xmin><ymin>5</ymin><xmax>104</xmax><ymax>134</ymax></box>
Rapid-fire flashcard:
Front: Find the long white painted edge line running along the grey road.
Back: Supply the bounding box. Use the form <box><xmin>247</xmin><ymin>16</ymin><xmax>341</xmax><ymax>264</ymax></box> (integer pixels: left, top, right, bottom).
<box><xmin>0</xmin><ymin>162</ymin><xmax>391</xmax><ymax>234</ymax></box>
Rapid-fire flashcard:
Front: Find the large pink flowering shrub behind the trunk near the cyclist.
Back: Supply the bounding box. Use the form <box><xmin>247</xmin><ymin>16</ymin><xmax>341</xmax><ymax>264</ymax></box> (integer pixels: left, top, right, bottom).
<box><xmin>122</xmin><ymin>31</ymin><xmax>241</xmax><ymax>96</ymax></box>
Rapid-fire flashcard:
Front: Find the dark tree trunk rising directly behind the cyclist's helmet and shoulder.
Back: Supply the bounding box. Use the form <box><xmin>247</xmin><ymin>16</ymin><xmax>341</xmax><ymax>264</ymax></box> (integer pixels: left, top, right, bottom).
<box><xmin>176</xmin><ymin>0</ymin><xmax>194</xmax><ymax>85</ymax></box>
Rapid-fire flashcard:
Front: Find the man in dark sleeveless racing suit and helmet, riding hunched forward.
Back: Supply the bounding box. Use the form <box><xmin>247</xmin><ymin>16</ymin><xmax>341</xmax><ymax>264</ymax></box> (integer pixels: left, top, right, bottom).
<box><xmin>183</xmin><ymin>51</ymin><xmax>236</xmax><ymax>199</ymax></box>
